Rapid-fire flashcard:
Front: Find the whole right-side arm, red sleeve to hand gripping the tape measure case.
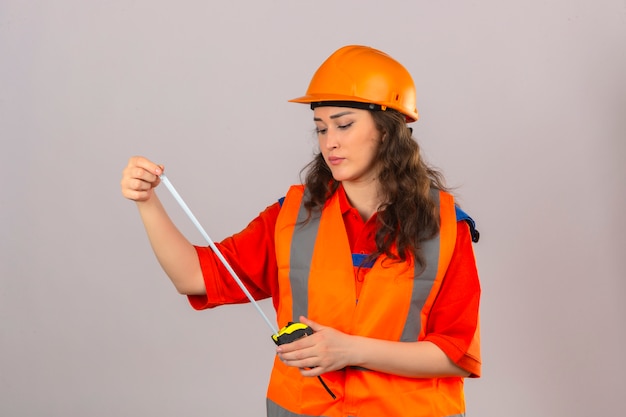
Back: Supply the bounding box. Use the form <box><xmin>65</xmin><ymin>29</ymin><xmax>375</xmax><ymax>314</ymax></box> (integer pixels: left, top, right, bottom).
<box><xmin>277</xmin><ymin>226</ymin><xmax>480</xmax><ymax>378</ymax></box>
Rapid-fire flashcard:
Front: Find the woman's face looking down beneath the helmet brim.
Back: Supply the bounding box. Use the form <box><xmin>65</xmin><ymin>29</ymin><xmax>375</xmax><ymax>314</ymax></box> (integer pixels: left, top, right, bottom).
<box><xmin>313</xmin><ymin>107</ymin><xmax>381</xmax><ymax>183</ymax></box>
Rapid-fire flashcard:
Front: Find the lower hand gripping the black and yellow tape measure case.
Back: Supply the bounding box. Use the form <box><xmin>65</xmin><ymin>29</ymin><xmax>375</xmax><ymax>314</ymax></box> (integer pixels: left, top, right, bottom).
<box><xmin>276</xmin><ymin>316</ymin><xmax>353</xmax><ymax>376</ymax></box>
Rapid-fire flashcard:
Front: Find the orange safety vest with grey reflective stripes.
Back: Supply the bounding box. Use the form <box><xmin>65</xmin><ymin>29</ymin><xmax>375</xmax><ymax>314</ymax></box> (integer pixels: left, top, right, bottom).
<box><xmin>267</xmin><ymin>185</ymin><xmax>465</xmax><ymax>417</ymax></box>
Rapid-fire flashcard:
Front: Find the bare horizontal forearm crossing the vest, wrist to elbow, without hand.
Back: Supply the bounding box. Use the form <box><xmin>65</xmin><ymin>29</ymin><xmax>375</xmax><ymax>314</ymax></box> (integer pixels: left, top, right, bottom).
<box><xmin>350</xmin><ymin>336</ymin><xmax>469</xmax><ymax>378</ymax></box>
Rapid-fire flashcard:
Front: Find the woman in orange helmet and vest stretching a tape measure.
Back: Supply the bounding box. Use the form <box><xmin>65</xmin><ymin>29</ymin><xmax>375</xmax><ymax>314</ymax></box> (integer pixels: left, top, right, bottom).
<box><xmin>121</xmin><ymin>45</ymin><xmax>481</xmax><ymax>417</ymax></box>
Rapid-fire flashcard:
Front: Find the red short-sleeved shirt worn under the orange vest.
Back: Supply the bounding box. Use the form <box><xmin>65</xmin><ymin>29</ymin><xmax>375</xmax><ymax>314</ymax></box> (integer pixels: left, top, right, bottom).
<box><xmin>189</xmin><ymin>188</ymin><xmax>480</xmax><ymax>416</ymax></box>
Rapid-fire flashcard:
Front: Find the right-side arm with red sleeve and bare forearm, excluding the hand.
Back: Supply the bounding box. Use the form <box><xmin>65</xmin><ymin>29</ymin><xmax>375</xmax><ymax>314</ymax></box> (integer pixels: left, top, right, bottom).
<box><xmin>354</xmin><ymin>222</ymin><xmax>480</xmax><ymax>377</ymax></box>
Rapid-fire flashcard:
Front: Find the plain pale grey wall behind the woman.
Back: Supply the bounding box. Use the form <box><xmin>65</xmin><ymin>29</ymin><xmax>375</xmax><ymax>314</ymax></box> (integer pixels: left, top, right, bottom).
<box><xmin>0</xmin><ymin>0</ymin><xmax>626</xmax><ymax>417</ymax></box>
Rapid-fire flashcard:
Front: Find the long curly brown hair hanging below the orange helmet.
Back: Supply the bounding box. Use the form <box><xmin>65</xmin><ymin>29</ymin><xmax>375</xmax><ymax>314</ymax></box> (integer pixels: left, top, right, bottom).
<box><xmin>302</xmin><ymin>109</ymin><xmax>448</xmax><ymax>267</ymax></box>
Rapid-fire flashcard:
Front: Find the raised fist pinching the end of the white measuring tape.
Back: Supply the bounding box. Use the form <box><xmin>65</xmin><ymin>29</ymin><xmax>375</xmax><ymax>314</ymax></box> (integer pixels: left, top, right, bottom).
<box><xmin>120</xmin><ymin>156</ymin><xmax>164</xmax><ymax>202</ymax></box>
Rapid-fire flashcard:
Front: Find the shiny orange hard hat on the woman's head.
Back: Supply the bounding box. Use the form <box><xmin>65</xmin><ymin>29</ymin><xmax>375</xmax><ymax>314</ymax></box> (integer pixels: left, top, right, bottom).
<box><xmin>289</xmin><ymin>45</ymin><xmax>419</xmax><ymax>123</ymax></box>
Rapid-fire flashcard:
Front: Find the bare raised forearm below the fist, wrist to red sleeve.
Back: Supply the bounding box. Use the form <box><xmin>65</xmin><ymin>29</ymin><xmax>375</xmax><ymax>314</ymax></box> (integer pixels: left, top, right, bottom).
<box><xmin>136</xmin><ymin>193</ymin><xmax>206</xmax><ymax>294</ymax></box>
